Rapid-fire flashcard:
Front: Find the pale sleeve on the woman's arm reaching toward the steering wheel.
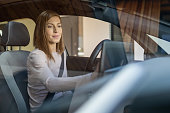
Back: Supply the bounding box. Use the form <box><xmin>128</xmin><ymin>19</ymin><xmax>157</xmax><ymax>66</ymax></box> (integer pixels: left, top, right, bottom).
<box><xmin>29</xmin><ymin>50</ymin><xmax>91</xmax><ymax>92</ymax></box>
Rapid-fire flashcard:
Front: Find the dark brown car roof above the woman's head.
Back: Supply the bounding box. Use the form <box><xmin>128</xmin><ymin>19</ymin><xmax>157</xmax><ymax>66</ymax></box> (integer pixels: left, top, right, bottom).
<box><xmin>0</xmin><ymin>0</ymin><xmax>94</xmax><ymax>22</ymax></box>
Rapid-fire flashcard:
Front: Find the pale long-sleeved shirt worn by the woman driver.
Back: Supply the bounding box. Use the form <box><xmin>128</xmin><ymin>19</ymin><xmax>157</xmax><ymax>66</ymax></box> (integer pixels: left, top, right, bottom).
<box><xmin>27</xmin><ymin>49</ymin><xmax>91</xmax><ymax>112</ymax></box>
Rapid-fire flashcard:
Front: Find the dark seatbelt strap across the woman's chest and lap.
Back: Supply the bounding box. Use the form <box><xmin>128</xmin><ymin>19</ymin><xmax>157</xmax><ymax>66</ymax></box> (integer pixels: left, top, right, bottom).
<box><xmin>43</xmin><ymin>53</ymin><xmax>64</xmax><ymax>104</ymax></box>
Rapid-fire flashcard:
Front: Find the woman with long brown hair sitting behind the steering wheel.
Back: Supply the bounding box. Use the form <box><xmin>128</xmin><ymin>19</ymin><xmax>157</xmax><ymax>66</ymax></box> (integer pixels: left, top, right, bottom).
<box><xmin>27</xmin><ymin>10</ymin><xmax>95</xmax><ymax>112</ymax></box>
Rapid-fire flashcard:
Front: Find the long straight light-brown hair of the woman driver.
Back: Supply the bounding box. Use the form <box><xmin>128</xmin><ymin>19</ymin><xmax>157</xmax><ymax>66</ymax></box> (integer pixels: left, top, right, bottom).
<box><xmin>33</xmin><ymin>10</ymin><xmax>64</xmax><ymax>60</ymax></box>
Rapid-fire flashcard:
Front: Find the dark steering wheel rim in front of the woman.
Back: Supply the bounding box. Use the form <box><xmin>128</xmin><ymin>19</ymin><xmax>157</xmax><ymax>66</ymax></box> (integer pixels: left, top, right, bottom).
<box><xmin>84</xmin><ymin>39</ymin><xmax>111</xmax><ymax>72</ymax></box>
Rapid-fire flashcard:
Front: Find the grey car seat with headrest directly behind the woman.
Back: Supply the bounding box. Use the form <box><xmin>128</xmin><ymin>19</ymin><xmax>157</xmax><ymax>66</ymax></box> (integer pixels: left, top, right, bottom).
<box><xmin>0</xmin><ymin>22</ymin><xmax>30</xmax><ymax>113</ymax></box>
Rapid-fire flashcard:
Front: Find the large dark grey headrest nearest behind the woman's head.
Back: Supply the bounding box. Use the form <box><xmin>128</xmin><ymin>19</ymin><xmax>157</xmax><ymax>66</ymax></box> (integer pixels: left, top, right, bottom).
<box><xmin>1</xmin><ymin>21</ymin><xmax>30</xmax><ymax>46</ymax></box>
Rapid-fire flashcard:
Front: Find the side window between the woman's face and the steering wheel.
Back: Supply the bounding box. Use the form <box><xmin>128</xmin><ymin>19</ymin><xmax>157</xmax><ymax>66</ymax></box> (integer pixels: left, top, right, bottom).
<box><xmin>61</xmin><ymin>16</ymin><xmax>111</xmax><ymax>57</ymax></box>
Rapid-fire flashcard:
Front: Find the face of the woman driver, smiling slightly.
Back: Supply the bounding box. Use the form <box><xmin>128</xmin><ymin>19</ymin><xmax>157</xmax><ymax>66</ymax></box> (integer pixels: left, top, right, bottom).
<box><xmin>45</xmin><ymin>16</ymin><xmax>62</xmax><ymax>44</ymax></box>
